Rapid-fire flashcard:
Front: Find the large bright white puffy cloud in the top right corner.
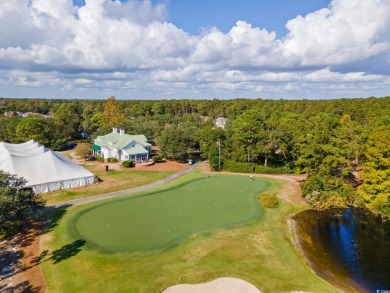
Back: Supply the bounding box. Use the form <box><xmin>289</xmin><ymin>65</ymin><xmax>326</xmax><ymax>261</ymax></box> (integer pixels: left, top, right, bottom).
<box><xmin>283</xmin><ymin>0</ymin><xmax>390</xmax><ymax>66</ymax></box>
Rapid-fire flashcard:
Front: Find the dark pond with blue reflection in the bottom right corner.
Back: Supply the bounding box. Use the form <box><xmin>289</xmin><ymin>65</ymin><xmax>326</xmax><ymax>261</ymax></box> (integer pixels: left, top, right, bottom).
<box><xmin>292</xmin><ymin>208</ymin><xmax>390</xmax><ymax>292</ymax></box>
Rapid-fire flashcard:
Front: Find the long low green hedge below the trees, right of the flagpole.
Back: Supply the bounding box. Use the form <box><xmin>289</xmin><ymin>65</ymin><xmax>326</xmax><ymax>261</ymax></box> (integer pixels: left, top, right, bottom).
<box><xmin>223</xmin><ymin>161</ymin><xmax>293</xmax><ymax>174</ymax></box>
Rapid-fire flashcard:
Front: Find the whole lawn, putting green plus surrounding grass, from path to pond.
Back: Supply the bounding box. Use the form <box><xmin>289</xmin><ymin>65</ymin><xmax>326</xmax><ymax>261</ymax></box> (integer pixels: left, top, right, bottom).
<box><xmin>41</xmin><ymin>171</ymin><xmax>337</xmax><ymax>292</ymax></box>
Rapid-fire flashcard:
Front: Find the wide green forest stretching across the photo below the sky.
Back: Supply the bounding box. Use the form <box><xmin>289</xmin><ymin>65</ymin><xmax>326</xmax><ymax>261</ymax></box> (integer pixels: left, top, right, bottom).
<box><xmin>0</xmin><ymin>97</ymin><xmax>390</xmax><ymax>218</ymax></box>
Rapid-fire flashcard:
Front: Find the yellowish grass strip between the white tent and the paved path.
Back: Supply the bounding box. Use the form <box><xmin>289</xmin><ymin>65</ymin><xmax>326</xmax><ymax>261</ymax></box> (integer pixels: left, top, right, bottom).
<box><xmin>42</xmin><ymin>165</ymin><xmax>175</xmax><ymax>204</ymax></box>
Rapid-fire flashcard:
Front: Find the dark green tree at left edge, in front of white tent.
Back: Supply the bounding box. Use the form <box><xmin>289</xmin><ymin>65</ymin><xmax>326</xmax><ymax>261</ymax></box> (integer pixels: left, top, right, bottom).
<box><xmin>0</xmin><ymin>170</ymin><xmax>44</xmax><ymax>238</ymax></box>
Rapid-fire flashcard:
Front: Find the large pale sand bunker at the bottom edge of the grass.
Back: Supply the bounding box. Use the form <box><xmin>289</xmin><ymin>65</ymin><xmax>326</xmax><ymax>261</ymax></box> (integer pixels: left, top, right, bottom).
<box><xmin>162</xmin><ymin>278</ymin><xmax>261</xmax><ymax>293</ymax></box>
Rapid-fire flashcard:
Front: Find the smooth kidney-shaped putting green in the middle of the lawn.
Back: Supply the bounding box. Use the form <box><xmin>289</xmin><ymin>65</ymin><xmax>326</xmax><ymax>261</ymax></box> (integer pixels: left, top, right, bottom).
<box><xmin>74</xmin><ymin>175</ymin><xmax>274</xmax><ymax>252</ymax></box>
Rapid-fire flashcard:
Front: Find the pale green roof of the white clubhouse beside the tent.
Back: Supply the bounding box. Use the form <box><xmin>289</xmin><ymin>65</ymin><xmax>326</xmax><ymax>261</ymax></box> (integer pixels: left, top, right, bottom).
<box><xmin>94</xmin><ymin>132</ymin><xmax>151</xmax><ymax>149</ymax></box>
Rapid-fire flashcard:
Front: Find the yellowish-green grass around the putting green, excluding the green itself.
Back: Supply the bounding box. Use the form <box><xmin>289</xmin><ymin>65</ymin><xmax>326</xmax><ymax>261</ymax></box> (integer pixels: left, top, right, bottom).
<box><xmin>41</xmin><ymin>172</ymin><xmax>337</xmax><ymax>292</ymax></box>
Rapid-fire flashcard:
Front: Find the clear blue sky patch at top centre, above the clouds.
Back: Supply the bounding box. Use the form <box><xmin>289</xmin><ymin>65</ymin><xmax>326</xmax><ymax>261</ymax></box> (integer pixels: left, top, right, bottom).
<box><xmin>73</xmin><ymin>0</ymin><xmax>330</xmax><ymax>37</ymax></box>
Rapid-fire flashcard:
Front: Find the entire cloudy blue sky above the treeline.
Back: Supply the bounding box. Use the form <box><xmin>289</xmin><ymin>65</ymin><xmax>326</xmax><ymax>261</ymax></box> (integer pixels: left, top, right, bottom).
<box><xmin>0</xmin><ymin>0</ymin><xmax>390</xmax><ymax>100</ymax></box>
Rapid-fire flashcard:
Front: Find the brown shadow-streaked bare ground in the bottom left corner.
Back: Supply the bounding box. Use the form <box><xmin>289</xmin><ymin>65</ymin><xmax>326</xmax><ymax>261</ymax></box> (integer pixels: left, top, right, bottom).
<box><xmin>0</xmin><ymin>220</ymin><xmax>46</xmax><ymax>293</ymax></box>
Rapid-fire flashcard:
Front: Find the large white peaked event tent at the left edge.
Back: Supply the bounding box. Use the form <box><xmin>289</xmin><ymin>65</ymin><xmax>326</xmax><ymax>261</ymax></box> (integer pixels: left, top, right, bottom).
<box><xmin>0</xmin><ymin>140</ymin><xmax>96</xmax><ymax>193</ymax></box>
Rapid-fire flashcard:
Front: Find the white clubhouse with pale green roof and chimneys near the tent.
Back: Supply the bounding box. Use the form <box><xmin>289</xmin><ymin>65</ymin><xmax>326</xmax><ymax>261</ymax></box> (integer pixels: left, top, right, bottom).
<box><xmin>92</xmin><ymin>127</ymin><xmax>152</xmax><ymax>163</ymax></box>
